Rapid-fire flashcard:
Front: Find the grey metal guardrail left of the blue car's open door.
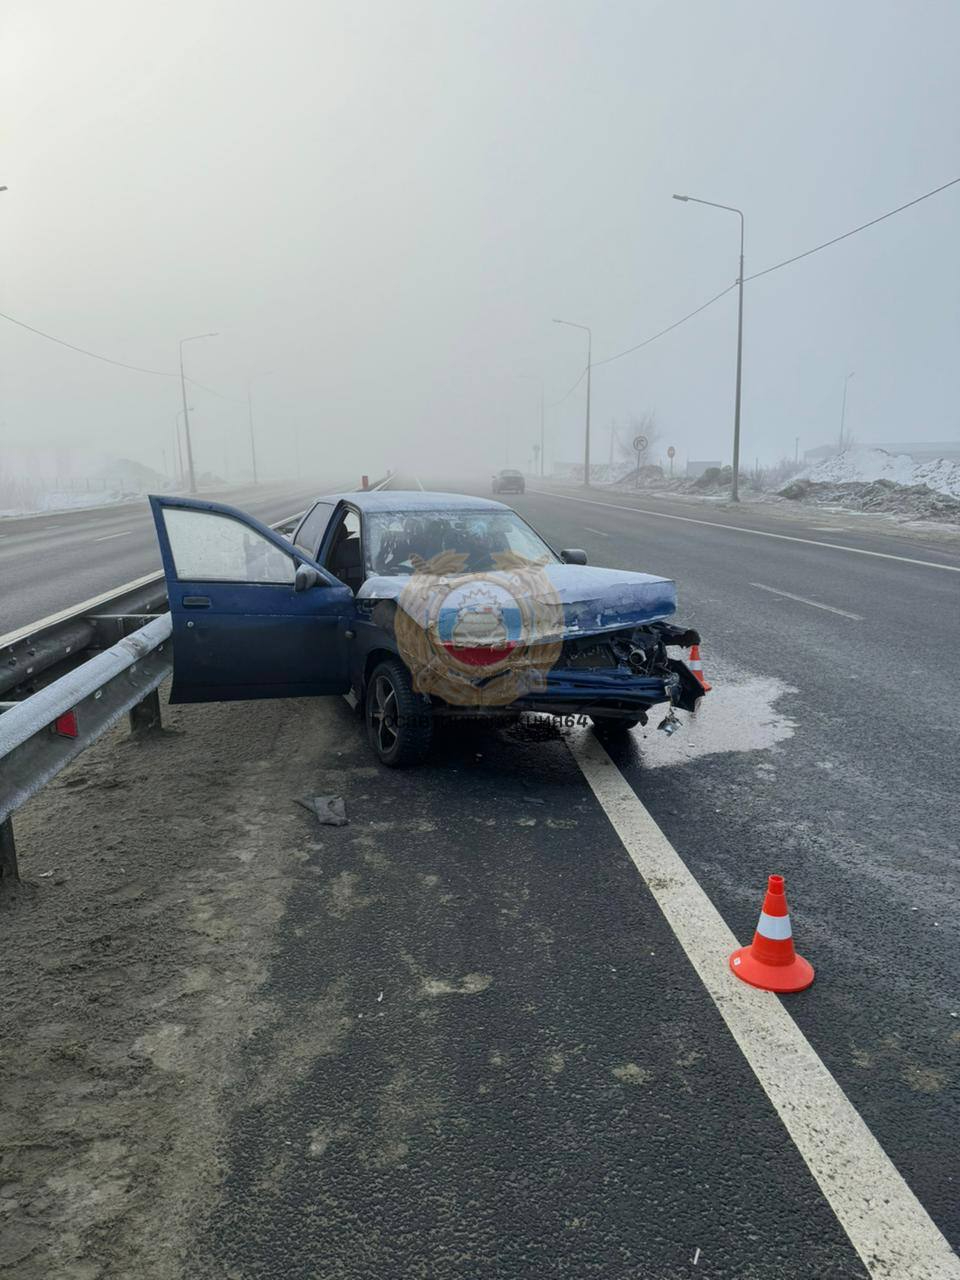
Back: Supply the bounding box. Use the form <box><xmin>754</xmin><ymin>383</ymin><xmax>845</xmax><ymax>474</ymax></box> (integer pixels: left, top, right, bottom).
<box><xmin>0</xmin><ymin>472</ymin><xmax>392</xmax><ymax>888</ymax></box>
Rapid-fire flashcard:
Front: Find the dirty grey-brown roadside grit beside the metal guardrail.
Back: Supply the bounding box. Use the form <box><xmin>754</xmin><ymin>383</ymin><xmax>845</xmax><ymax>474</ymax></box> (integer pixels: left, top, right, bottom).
<box><xmin>0</xmin><ymin>694</ymin><xmax>349</xmax><ymax>1280</ymax></box>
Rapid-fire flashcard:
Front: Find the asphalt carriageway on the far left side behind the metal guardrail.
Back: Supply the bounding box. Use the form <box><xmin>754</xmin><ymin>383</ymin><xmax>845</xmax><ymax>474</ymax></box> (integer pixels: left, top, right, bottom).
<box><xmin>0</xmin><ymin>480</ymin><xmax>345</xmax><ymax>635</ymax></box>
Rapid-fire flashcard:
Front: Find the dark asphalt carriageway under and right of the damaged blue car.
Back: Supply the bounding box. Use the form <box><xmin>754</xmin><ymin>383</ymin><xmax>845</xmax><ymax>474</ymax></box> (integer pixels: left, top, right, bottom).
<box><xmin>200</xmin><ymin>480</ymin><xmax>960</xmax><ymax>1277</ymax></box>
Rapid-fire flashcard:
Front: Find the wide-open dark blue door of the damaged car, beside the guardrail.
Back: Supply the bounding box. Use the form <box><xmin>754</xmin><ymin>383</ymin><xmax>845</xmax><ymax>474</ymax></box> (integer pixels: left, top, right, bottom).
<box><xmin>150</xmin><ymin>498</ymin><xmax>355</xmax><ymax>703</ymax></box>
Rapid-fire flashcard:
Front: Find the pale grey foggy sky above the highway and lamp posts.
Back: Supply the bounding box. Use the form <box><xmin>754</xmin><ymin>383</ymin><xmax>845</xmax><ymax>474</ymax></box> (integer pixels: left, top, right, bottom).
<box><xmin>0</xmin><ymin>0</ymin><xmax>960</xmax><ymax>477</ymax></box>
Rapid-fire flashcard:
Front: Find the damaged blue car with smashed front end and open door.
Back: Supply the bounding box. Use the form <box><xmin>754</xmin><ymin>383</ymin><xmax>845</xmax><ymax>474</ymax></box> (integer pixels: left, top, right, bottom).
<box><xmin>150</xmin><ymin>490</ymin><xmax>705</xmax><ymax>765</ymax></box>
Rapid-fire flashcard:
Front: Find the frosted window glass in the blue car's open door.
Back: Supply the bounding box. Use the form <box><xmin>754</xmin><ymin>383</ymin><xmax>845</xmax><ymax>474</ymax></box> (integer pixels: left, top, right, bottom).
<box><xmin>164</xmin><ymin>507</ymin><xmax>294</xmax><ymax>585</ymax></box>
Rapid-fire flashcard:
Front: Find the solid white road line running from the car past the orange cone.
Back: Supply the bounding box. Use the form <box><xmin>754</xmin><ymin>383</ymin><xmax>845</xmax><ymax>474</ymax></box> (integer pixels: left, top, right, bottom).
<box><xmin>568</xmin><ymin>731</ymin><xmax>960</xmax><ymax>1280</ymax></box>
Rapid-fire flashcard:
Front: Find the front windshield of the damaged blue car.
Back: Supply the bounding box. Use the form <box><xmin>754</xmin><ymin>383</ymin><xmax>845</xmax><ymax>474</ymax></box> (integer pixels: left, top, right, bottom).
<box><xmin>366</xmin><ymin>511</ymin><xmax>558</xmax><ymax>575</ymax></box>
